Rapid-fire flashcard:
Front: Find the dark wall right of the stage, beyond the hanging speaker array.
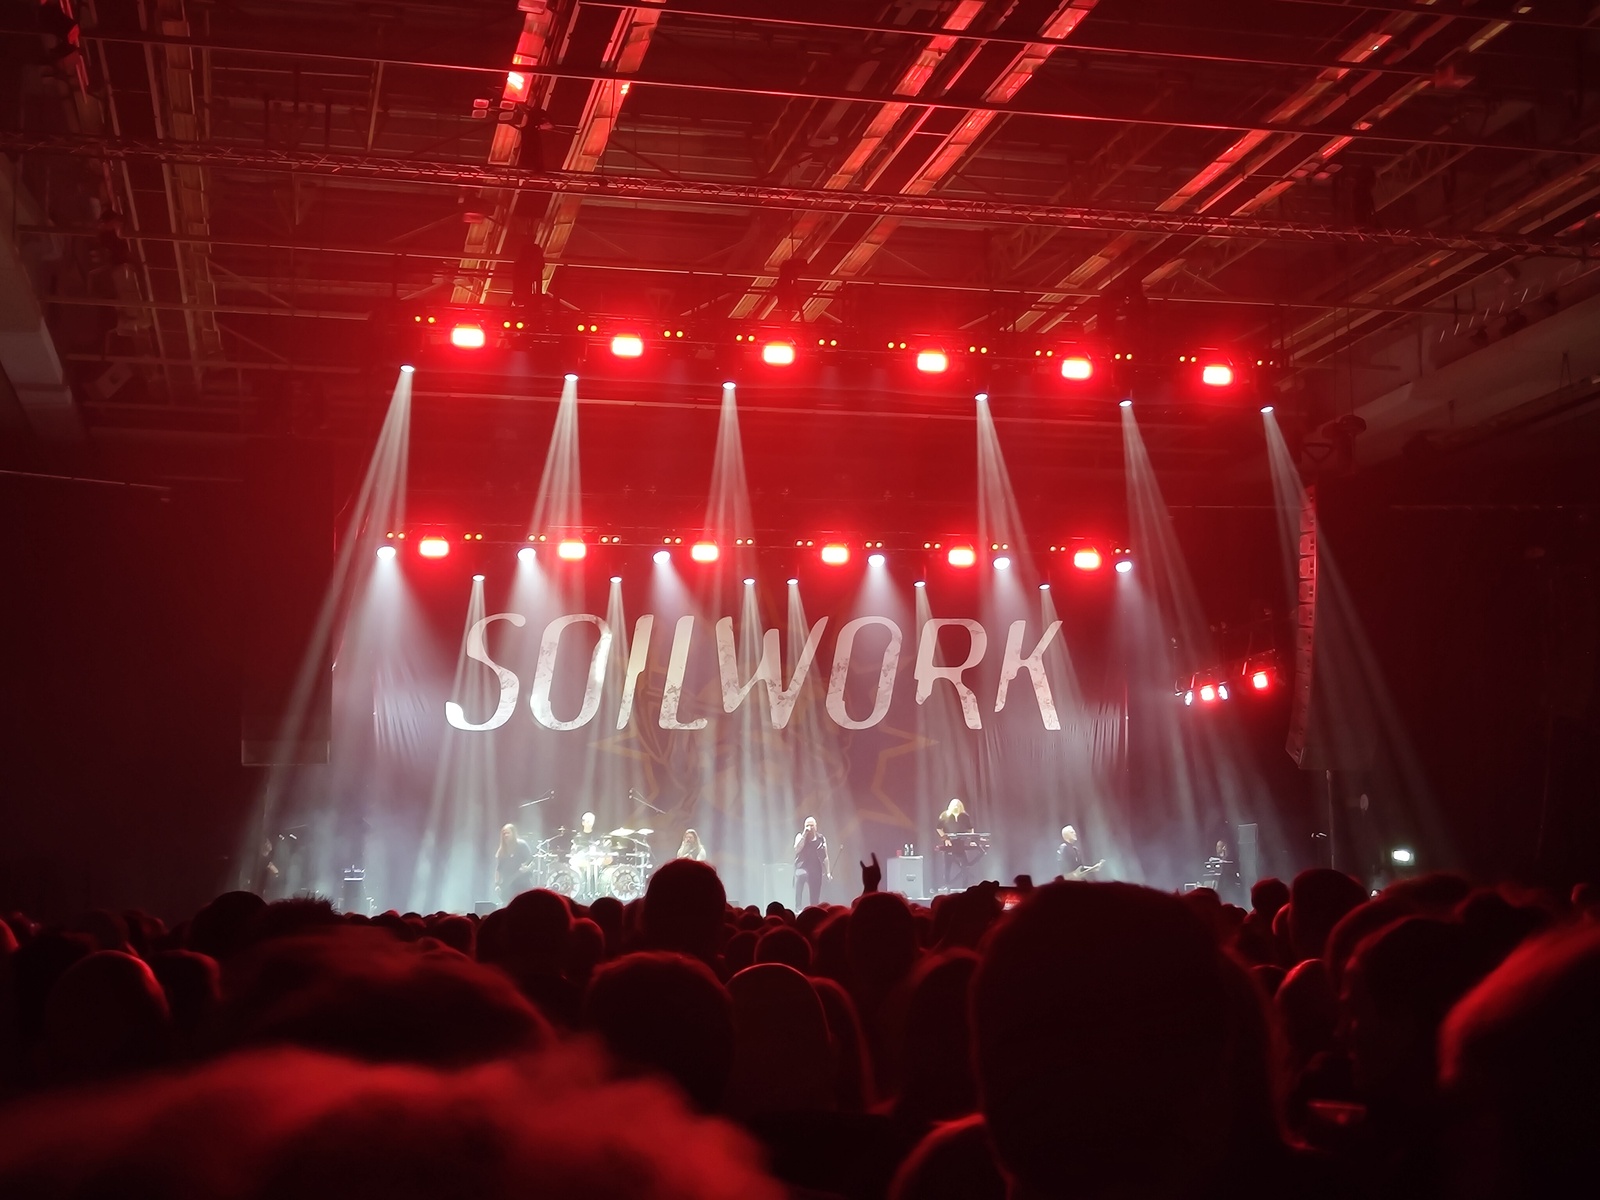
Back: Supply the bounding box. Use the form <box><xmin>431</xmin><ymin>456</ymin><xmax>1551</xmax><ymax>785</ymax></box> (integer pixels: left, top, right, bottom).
<box><xmin>1322</xmin><ymin>446</ymin><xmax>1600</xmax><ymax>885</ymax></box>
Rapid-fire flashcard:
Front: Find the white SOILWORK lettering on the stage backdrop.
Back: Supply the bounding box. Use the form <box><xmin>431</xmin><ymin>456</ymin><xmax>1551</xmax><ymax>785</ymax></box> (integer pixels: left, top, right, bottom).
<box><xmin>445</xmin><ymin>613</ymin><xmax>1061</xmax><ymax>733</ymax></box>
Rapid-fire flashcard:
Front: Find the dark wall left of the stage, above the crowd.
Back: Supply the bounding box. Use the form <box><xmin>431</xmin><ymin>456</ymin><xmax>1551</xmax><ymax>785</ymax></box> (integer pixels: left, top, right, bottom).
<box><xmin>0</xmin><ymin>478</ymin><xmax>251</xmax><ymax>917</ymax></box>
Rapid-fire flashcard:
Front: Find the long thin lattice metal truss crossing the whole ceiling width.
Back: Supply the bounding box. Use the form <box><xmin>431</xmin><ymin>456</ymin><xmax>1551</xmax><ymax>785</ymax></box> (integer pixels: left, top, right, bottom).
<box><xmin>0</xmin><ymin>133</ymin><xmax>1582</xmax><ymax>254</ymax></box>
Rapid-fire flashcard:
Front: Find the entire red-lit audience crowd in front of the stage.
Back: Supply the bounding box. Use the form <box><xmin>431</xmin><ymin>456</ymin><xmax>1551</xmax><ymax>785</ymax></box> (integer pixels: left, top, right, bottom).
<box><xmin>0</xmin><ymin>858</ymin><xmax>1600</xmax><ymax>1200</ymax></box>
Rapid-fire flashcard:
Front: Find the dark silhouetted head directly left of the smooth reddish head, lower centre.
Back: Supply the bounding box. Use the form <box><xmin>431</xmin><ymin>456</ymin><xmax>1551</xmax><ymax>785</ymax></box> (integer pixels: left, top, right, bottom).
<box><xmin>582</xmin><ymin>952</ymin><xmax>733</xmax><ymax>1112</ymax></box>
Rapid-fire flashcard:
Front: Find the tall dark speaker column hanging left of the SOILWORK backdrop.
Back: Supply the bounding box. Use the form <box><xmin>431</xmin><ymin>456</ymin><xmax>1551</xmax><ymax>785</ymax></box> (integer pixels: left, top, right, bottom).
<box><xmin>238</xmin><ymin>437</ymin><xmax>334</xmax><ymax>766</ymax></box>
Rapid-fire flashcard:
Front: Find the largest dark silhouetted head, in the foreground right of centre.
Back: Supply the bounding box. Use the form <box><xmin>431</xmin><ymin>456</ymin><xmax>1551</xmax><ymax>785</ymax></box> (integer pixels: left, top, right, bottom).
<box><xmin>971</xmin><ymin>883</ymin><xmax>1266</xmax><ymax>1197</ymax></box>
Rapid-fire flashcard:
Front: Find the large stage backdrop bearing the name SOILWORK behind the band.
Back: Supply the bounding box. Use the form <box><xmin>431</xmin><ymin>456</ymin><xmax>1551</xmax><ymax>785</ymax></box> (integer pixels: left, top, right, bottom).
<box><xmin>267</xmin><ymin>562</ymin><xmax>1126</xmax><ymax>910</ymax></box>
